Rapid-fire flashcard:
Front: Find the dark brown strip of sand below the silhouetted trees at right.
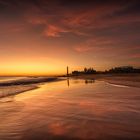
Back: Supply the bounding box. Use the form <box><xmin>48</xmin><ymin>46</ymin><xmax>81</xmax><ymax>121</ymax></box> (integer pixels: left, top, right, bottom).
<box><xmin>72</xmin><ymin>74</ymin><xmax>140</xmax><ymax>88</ymax></box>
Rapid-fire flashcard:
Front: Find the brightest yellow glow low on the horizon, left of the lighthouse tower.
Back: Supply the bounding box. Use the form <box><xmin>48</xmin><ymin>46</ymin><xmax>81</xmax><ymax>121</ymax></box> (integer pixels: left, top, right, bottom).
<box><xmin>0</xmin><ymin>62</ymin><xmax>65</xmax><ymax>76</ymax></box>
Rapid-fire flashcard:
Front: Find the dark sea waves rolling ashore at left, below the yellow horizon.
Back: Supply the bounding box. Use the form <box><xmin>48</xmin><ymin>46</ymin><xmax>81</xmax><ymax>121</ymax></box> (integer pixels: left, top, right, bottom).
<box><xmin>0</xmin><ymin>77</ymin><xmax>57</xmax><ymax>98</ymax></box>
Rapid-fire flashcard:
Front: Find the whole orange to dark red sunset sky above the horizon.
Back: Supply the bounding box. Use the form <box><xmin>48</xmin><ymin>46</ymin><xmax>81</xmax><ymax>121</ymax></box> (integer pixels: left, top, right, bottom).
<box><xmin>0</xmin><ymin>0</ymin><xmax>140</xmax><ymax>75</ymax></box>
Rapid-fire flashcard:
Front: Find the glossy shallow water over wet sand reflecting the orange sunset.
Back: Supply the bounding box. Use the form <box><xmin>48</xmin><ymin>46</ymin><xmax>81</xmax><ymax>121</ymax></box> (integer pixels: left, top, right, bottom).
<box><xmin>0</xmin><ymin>79</ymin><xmax>140</xmax><ymax>140</ymax></box>
